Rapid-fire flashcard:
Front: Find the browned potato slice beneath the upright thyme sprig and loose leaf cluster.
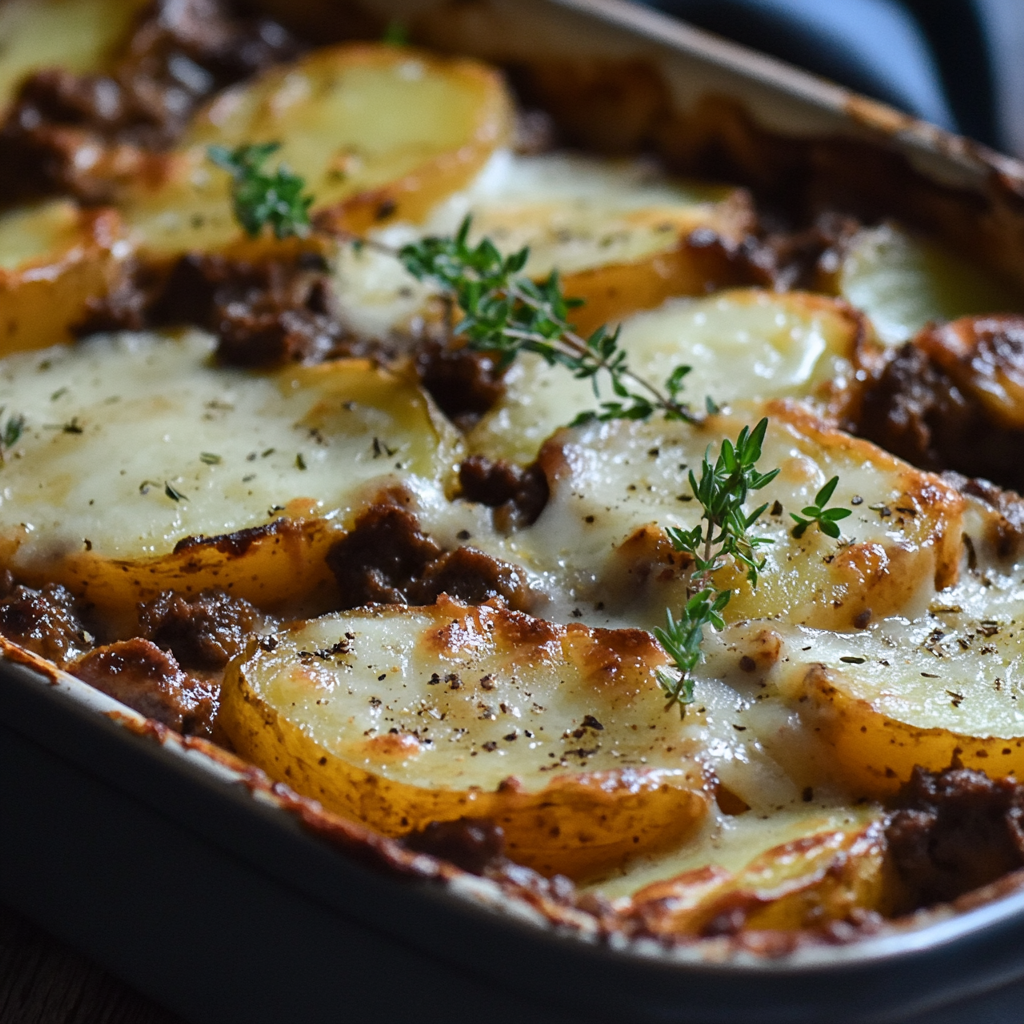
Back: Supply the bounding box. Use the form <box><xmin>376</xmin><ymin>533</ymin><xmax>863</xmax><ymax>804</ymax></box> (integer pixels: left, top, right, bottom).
<box><xmin>516</xmin><ymin>402</ymin><xmax>964</xmax><ymax>630</ymax></box>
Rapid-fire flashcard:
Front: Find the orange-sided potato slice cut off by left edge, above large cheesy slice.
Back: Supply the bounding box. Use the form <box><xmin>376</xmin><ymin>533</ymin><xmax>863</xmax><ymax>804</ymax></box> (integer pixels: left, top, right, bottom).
<box><xmin>0</xmin><ymin>200</ymin><xmax>129</xmax><ymax>355</ymax></box>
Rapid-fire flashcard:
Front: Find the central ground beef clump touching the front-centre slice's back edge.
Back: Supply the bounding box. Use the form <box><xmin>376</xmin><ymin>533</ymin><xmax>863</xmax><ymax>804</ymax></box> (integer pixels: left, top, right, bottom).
<box><xmin>327</xmin><ymin>502</ymin><xmax>528</xmax><ymax>609</ymax></box>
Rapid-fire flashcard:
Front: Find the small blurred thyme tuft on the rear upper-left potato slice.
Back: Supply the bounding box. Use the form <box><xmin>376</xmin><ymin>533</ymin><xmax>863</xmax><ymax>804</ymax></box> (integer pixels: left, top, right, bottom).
<box><xmin>206</xmin><ymin>142</ymin><xmax>313</xmax><ymax>239</ymax></box>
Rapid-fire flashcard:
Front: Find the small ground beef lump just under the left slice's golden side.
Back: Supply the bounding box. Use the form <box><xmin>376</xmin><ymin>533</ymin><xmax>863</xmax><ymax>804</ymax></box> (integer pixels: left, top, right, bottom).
<box><xmin>139</xmin><ymin>590</ymin><xmax>268</xmax><ymax>670</ymax></box>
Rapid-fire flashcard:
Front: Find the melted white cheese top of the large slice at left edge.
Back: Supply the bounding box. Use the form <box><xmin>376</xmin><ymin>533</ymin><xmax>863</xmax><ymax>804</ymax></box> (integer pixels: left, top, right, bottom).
<box><xmin>0</xmin><ymin>332</ymin><xmax>457</xmax><ymax>564</ymax></box>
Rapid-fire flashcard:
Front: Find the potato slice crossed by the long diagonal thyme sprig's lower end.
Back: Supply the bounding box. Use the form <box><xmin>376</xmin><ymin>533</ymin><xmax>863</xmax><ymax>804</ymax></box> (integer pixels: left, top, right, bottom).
<box><xmin>469</xmin><ymin>289</ymin><xmax>878</xmax><ymax>463</ymax></box>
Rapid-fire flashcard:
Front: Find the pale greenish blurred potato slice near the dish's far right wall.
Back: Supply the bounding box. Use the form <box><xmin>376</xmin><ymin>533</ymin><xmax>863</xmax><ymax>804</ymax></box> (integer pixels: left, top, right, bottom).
<box><xmin>836</xmin><ymin>224</ymin><xmax>1024</xmax><ymax>345</ymax></box>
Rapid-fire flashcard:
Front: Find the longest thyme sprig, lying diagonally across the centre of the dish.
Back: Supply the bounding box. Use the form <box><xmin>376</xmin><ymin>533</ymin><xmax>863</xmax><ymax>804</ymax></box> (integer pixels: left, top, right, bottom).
<box><xmin>397</xmin><ymin>217</ymin><xmax>697</xmax><ymax>425</ymax></box>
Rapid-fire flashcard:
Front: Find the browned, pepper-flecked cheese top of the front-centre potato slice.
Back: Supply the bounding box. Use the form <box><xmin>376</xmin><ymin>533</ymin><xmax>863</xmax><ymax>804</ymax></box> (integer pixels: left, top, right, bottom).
<box><xmin>236</xmin><ymin>600</ymin><xmax>700</xmax><ymax>791</ymax></box>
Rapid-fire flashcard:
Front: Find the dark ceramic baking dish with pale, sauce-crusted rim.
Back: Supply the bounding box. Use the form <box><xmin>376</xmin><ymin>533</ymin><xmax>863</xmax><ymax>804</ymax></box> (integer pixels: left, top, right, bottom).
<box><xmin>6</xmin><ymin>0</ymin><xmax>1024</xmax><ymax>1024</ymax></box>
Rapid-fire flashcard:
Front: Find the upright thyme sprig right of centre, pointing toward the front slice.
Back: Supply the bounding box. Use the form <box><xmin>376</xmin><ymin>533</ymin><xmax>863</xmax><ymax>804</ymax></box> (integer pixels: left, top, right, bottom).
<box><xmin>654</xmin><ymin>419</ymin><xmax>779</xmax><ymax>715</ymax></box>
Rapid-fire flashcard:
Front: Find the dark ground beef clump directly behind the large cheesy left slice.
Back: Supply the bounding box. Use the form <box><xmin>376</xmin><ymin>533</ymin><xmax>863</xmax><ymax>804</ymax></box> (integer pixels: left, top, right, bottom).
<box><xmin>76</xmin><ymin>253</ymin><xmax>366</xmax><ymax>367</ymax></box>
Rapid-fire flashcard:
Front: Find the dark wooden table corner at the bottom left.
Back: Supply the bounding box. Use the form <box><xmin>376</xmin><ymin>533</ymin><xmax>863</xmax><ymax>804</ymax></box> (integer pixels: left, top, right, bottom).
<box><xmin>0</xmin><ymin>905</ymin><xmax>182</xmax><ymax>1024</ymax></box>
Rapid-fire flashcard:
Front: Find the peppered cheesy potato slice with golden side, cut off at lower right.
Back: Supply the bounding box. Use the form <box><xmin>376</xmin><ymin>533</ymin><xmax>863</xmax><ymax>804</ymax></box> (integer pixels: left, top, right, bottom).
<box><xmin>769</xmin><ymin>574</ymin><xmax>1024</xmax><ymax>796</ymax></box>
